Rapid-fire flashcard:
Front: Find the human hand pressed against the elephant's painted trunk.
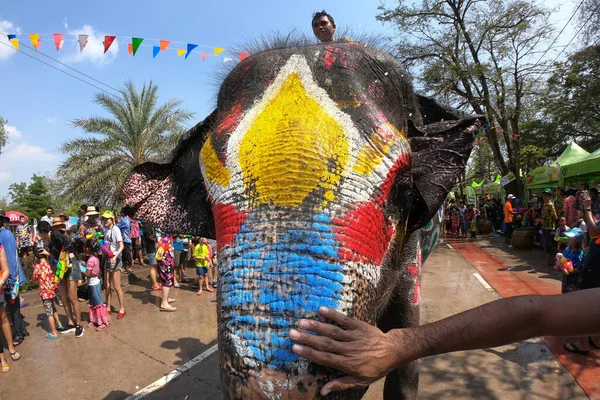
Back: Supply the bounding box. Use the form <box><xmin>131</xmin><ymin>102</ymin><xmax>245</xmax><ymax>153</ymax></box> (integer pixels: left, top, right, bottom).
<box><xmin>289</xmin><ymin>307</ymin><xmax>408</xmax><ymax>396</ymax></box>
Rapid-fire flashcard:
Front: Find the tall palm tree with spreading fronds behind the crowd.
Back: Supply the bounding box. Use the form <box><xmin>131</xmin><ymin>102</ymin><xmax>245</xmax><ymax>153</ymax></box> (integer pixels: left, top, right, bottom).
<box><xmin>58</xmin><ymin>81</ymin><xmax>193</xmax><ymax>206</ymax></box>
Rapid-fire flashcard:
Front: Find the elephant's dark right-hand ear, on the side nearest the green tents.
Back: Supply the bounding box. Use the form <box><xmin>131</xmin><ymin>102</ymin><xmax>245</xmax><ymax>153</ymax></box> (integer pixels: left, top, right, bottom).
<box><xmin>395</xmin><ymin>108</ymin><xmax>483</xmax><ymax>230</ymax></box>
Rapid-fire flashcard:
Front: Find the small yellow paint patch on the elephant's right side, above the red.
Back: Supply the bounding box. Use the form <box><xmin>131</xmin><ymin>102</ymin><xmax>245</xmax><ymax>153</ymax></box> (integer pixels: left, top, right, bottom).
<box><xmin>352</xmin><ymin>123</ymin><xmax>404</xmax><ymax>176</ymax></box>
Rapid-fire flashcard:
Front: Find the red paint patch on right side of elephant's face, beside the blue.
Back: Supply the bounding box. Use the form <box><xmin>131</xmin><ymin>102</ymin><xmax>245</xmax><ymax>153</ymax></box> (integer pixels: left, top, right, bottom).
<box><xmin>333</xmin><ymin>202</ymin><xmax>394</xmax><ymax>266</ymax></box>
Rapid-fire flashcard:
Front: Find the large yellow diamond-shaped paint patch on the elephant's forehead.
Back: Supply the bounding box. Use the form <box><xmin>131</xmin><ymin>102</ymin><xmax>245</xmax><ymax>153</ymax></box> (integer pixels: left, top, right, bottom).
<box><xmin>239</xmin><ymin>72</ymin><xmax>350</xmax><ymax>207</ymax></box>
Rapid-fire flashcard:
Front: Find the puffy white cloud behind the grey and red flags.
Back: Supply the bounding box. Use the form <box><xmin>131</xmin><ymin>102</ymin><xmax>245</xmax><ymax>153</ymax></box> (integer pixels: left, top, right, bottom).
<box><xmin>63</xmin><ymin>21</ymin><xmax>119</xmax><ymax>66</ymax></box>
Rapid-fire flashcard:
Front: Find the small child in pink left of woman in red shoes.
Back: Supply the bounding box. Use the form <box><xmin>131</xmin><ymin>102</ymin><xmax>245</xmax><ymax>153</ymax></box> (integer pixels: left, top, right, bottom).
<box><xmin>85</xmin><ymin>239</ymin><xmax>110</xmax><ymax>332</ymax></box>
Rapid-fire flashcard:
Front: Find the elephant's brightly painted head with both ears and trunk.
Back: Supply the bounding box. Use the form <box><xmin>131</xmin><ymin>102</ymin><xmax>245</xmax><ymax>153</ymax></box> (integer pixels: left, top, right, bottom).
<box><xmin>123</xmin><ymin>42</ymin><xmax>479</xmax><ymax>399</ymax></box>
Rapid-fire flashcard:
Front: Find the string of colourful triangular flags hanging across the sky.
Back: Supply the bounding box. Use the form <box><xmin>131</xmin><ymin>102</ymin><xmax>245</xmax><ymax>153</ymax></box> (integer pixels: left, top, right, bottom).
<box><xmin>7</xmin><ymin>33</ymin><xmax>250</xmax><ymax>62</ymax></box>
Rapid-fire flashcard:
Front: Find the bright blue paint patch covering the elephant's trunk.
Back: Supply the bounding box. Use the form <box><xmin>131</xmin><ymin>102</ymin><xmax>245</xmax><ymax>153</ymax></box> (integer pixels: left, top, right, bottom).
<box><xmin>221</xmin><ymin>213</ymin><xmax>344</xmax><ymax>368</ymax></box>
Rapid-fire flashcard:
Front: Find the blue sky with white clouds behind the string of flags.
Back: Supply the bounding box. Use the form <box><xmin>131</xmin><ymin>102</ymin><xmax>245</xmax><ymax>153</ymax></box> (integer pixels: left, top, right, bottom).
<box><xmin>0</xmin><ymin>0</ymin><xmax>572</xmax><ymax>197</ymax></box>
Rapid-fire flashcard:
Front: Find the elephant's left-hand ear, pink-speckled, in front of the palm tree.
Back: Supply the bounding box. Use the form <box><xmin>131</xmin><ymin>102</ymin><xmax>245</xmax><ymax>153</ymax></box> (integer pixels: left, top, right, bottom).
<box><xmin>121</xmin><ymin>112</ymin><xmax>215</xmax><ymax>238</ymax></box>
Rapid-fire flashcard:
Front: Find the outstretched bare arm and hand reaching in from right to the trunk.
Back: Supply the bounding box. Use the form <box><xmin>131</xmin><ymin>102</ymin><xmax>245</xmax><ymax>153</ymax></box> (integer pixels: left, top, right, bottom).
<box><xmin>289</xmin><ymin>288</ymin><xmax>600</xmax><ymax>396</ymax></box>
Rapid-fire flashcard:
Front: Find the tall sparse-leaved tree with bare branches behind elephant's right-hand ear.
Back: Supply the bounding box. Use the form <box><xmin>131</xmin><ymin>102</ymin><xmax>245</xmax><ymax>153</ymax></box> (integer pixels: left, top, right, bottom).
<box><xmin>377</xmin><ymin>0</ymin><xmax>553</xmax><ymax>193</ymax></box>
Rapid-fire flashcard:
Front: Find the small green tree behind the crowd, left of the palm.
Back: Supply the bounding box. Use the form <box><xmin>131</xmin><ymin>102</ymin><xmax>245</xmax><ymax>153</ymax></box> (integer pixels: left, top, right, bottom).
<box><xmin>8</xmin><ymin>174</ymin><xmax>52</xmax><ymax>218</ymax></box>
